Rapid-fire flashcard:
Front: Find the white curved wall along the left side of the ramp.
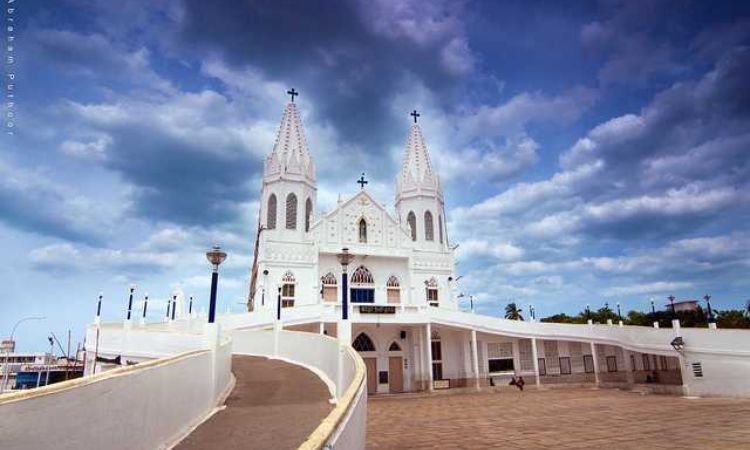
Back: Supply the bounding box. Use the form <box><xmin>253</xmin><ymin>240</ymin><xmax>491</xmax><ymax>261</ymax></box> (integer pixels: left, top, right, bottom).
<box><xmin>0</xmin><ymin>346</ymin><xmax>231</xmax><ymax>450</ymax></box>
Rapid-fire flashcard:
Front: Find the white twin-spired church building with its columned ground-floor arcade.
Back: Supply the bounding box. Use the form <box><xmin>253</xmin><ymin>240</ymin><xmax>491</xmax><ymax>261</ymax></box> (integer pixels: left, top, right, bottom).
<box><xmin>248</xmin><ymin>97</ymin><xmax>682</xmax><ymax>393</ymax></box>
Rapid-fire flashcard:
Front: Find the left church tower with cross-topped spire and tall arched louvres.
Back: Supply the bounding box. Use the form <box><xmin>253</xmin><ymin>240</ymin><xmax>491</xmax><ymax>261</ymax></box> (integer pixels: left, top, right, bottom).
<box><xmin>248</xmin><ymin>89</ymin><xmax>317</xmax><ymax>311</ymax></box>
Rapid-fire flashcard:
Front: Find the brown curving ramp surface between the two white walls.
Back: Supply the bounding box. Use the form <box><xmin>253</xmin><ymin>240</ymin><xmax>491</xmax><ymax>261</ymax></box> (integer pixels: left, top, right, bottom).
<box><xmin>176</xmin><ymin>356</ymin><xmax>333</xmax><ymax>450</ymax></box>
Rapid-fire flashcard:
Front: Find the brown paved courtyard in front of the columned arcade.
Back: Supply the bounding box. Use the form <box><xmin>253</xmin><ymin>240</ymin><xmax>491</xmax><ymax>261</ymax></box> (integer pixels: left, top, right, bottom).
<box><xmin>367</xmin><ymin>389</ymin><xmax>750</xmax><ymax>450</ymax></box>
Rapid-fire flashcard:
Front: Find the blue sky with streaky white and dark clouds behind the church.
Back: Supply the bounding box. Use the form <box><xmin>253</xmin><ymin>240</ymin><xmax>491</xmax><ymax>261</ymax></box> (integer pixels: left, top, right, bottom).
<box><xmin>0</xmin><ymin>0</ymin><xmax>750</xmax><ymax>349</ymax></box>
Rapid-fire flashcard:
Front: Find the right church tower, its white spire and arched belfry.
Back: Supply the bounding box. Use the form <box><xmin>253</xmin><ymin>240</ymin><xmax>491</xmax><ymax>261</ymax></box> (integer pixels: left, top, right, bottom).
<box><xmin>396</xmin><ymin>111</ymin><xmax>448</xmax><ymax>251</ymax></box>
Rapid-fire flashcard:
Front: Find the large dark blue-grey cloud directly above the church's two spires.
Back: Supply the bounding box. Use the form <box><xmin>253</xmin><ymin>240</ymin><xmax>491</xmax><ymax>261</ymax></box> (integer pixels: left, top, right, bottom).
<box><xmin>177</xmin><ymin>1</ymin><xmax>470</xmax><ymax>170</ymax></box>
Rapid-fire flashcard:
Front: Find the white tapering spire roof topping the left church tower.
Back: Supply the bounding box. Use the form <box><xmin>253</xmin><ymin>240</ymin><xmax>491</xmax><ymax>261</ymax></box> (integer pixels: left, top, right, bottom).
<box><xmin>265</xmin><ymin>102</ymin><xmax>315</xmax><ymax>182</ymax></box>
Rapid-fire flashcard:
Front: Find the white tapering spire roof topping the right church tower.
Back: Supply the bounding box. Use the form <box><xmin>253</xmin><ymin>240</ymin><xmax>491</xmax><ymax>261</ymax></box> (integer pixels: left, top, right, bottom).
<box><xmin>396</xmin><ymin>123</ymin><xmax>441</xmax><ymax>197</ymax></box>
